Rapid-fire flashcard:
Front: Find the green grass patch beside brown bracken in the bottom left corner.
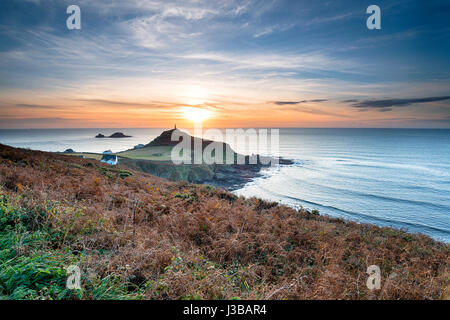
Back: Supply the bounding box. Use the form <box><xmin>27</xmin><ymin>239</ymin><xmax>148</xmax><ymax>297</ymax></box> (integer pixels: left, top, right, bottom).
<box><xmin>0</xmin><ymin>195</ymin><xmax>142</xmax><ymax>300</ymax></box>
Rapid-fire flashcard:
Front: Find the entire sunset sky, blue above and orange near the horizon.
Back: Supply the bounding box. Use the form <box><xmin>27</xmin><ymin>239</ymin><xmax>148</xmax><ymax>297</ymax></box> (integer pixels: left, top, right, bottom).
<box><xmin>0</xmin><ymin>0</ymin><xmax>450</xmax><ymax>128</ymax></box>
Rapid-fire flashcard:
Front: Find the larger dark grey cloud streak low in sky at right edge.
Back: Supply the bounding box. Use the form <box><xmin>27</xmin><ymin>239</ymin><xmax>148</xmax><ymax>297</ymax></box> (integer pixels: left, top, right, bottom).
<box><xmin>352</xmin><ymin>96</ymin><xmax>450</xmax><ymax>112</ymax></box>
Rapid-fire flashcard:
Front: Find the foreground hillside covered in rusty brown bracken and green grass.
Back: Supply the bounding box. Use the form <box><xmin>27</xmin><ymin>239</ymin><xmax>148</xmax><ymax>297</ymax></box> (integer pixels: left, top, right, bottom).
<box><xmin>0</xmin><ymin>146</ymin><xmax>449</xmax><ymax>299</ymax></box>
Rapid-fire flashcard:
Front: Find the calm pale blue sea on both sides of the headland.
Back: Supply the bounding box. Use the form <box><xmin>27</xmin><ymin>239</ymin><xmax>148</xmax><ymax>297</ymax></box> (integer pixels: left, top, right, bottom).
<box><xmin>0</xmin><ymin>128</ymin><xmax>450</xmax><ymax>243</ymax></box>
